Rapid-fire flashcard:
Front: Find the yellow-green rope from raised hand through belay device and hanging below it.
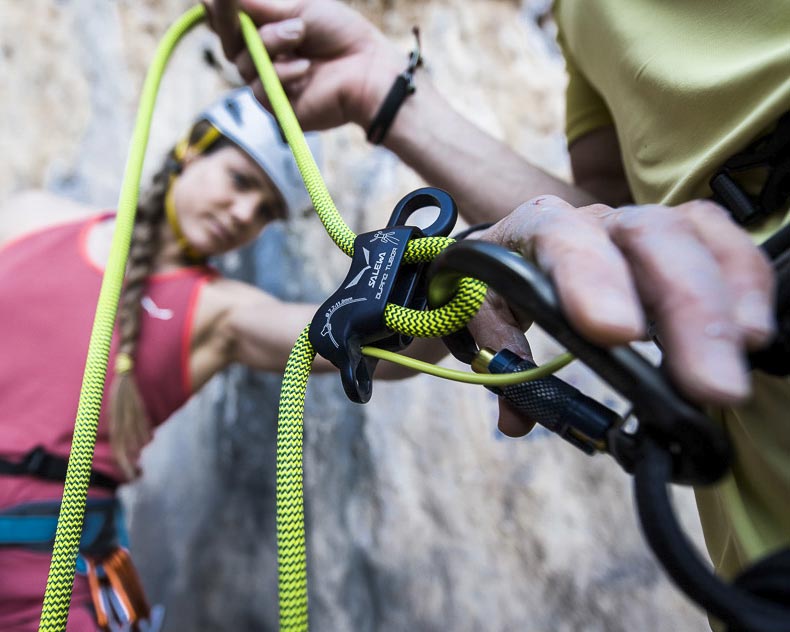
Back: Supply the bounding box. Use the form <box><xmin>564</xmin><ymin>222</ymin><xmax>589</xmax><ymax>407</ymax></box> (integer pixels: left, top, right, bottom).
<box><xmin>240</xmin><ymin>14</ymin><xmax>496</xmax><ymax>630</ymax></box>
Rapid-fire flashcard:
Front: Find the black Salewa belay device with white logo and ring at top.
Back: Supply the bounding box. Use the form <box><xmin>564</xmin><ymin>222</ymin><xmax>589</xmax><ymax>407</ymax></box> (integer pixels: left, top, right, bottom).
<box><xmin>309</xmin><ymin>187</ymin><xmax>458</xmax><ymax>404</ymax></box>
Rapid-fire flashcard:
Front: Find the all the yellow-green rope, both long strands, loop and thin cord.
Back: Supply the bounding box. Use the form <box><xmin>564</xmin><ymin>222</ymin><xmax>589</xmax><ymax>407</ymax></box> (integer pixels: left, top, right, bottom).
<box><xmin>39</xmin><ymin>5</ymin><xmax>569</xmax><ymax>632</ymax></box>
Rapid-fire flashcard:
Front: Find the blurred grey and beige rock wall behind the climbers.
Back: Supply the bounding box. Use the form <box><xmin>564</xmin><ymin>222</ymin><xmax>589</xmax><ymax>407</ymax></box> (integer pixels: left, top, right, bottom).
<box><xmin>0</xmin><ymin>0</ymin><xmax>706</xmax><ymax>632</ymax></box>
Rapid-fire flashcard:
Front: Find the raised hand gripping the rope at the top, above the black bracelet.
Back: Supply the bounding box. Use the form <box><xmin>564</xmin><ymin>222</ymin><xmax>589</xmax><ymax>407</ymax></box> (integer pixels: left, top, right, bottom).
<box><xmin>204</xmin><ymin>0</ymin><xmax>407</xmax><ymax>129</ymax></box>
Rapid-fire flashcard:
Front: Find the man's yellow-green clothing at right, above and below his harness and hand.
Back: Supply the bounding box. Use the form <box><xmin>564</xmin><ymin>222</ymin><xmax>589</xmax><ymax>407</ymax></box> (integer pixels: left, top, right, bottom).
<box><xmin>555</xmin><ymin>0</ymin><xmax>790</xmax><ymax>577</ymax></box>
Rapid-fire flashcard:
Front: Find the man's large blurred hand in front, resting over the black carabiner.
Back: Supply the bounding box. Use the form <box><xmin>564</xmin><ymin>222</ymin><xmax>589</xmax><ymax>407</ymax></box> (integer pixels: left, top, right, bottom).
<box><xmin>476</xmin><ymin>196</ymin><xmax>776</xmax><ymax>434</ymax></box>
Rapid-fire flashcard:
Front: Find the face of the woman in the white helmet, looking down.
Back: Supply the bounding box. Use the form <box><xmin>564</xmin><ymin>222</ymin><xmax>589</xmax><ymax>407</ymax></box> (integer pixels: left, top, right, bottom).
<box><xmin>173</xmin><ymin>146</ymin><xmax>282</xmax><ymax>255</ymax></box>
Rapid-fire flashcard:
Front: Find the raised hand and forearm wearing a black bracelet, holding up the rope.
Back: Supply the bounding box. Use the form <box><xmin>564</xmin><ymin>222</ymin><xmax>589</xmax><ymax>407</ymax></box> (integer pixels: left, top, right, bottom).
<box><xmin>211</xmin><ymin>0</ymin><xmax>595</xmax><ymax>223</ymax></box>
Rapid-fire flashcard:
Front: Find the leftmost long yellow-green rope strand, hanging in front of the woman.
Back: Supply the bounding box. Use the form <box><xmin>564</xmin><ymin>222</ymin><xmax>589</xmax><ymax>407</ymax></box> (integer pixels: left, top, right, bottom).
<box><xmin>39</xmin><ymin>6</ymin><xmax>204</xmax><ymax>632</ymax></box>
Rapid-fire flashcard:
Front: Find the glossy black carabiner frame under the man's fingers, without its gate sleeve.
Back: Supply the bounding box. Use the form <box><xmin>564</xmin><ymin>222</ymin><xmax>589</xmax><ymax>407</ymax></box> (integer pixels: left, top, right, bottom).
<box><xmin>428</xmin><ymin>241</ymin><xmax>730</xmax><ymax>485</ymax></box>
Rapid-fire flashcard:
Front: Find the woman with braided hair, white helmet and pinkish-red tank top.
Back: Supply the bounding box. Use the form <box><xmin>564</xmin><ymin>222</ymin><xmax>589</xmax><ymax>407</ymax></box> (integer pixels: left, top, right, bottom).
<box><xmin>0</xmin><ymin>89</ymin><xmax>338</xmax><ymax>632</ymax></box>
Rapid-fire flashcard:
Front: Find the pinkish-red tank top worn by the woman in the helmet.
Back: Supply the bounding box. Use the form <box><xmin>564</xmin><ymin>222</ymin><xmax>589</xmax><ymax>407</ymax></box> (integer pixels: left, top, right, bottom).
<box><xmin>0</xmin><ymin>214</ymin><xmax>214</xmax><ymax>507</ymax></box>
